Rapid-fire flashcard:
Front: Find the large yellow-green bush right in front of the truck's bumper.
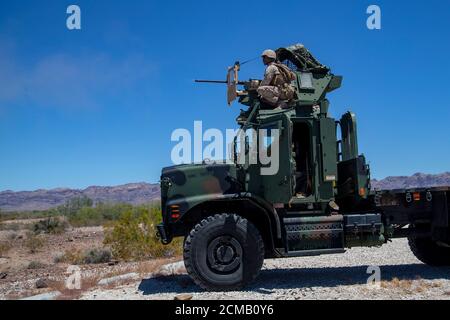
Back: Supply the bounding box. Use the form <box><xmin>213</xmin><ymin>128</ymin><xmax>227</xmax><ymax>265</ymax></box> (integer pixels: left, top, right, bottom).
<box><xmin>104</xmin><ymin>207</ymin><xmax>182</xmax><ymax>260</ymax></box>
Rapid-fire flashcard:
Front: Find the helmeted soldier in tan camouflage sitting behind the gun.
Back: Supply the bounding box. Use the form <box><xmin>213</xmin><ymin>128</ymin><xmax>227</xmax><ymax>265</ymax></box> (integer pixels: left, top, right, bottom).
<box><xmin>257</xmin><ymin>49</ymin><xmax>295</xmax><ymax>109</ymax></box>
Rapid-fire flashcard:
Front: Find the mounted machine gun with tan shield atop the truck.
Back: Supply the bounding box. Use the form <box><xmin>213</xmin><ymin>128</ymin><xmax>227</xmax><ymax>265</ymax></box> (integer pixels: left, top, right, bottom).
<box><xmin>194</xmin><ymin>61</ymin><xmax>260</xmax><ymax>106</ymax></box>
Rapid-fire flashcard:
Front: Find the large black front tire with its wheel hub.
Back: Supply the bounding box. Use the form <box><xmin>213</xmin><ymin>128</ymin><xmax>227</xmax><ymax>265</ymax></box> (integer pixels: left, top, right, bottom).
<box><xmin>183</xmin><ymin>214</ymin><xmax>264</xmax><ymax>291</ymax></box>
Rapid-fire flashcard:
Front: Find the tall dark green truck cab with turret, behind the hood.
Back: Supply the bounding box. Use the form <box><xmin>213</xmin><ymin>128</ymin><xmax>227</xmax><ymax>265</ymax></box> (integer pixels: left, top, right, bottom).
<box><xmin>232</xmin><ymin>45</ymin><xmax>369</xmax><ymax>211</ymax></box>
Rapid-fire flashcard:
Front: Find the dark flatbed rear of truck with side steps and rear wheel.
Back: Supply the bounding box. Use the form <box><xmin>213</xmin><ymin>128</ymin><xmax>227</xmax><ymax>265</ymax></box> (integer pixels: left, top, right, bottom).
<box><xmin>250</xmin><ymin>187</ymin><xmax>450</xmax><ymax>265</ymax></box>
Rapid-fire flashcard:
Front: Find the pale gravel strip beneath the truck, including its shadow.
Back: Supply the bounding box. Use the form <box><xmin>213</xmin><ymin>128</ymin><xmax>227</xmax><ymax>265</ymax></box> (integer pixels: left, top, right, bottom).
<box><xmin>81</xmin><ymin>239</ymin><xmax>450</xmax><ymax>300</ymax></box>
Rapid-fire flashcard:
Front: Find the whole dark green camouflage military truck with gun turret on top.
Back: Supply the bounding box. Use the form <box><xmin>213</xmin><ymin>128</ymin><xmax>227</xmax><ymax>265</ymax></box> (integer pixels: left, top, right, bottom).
<box><xmin>158</xmin><ymin>45</ymin><xmax>450</xmax><ymax>290</ymax></box>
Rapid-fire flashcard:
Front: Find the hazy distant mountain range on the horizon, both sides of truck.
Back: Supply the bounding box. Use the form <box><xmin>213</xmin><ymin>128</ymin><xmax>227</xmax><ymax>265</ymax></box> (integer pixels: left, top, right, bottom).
<box><xmin>0</xmin><ymin>172</ymin><xmax>450</xmax><ymax>211</ymax></box>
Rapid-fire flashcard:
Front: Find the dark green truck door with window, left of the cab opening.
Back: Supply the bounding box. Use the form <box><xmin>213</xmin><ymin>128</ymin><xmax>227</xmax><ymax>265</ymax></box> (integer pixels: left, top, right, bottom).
<box><xmin>258</xmin><ymin>115</ymin><xmax>295</xmax><ymax>203</ymax></box>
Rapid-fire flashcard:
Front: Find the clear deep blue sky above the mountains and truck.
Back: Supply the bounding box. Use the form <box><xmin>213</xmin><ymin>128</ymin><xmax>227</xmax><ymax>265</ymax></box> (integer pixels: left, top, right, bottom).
<box><xmin>0</xmin><ymin>0</ymin><xmax>450</xmax><ymax>190</ymax></box>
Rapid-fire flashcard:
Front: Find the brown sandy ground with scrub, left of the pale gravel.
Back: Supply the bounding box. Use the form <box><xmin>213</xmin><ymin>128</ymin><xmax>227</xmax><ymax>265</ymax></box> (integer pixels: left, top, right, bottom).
<box><xmin>0</xmin><ymin>220</ymin><xmax>174</xmax><ymax>300</ymax></box>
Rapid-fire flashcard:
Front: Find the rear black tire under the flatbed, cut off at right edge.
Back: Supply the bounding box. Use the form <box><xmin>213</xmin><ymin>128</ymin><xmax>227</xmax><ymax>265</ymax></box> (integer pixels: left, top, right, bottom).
<box><xmin>408</xmin><ymin>232</ymin><xmax>450</xmax><ymax>267</ymax></box>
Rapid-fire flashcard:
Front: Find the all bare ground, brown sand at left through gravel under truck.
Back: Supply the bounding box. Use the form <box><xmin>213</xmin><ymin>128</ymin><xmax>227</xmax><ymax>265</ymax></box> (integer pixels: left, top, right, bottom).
<box><xmin>0</xmin><ymin>218</ymin><xmax>450</xmax><ymax>300</ymax></box>
